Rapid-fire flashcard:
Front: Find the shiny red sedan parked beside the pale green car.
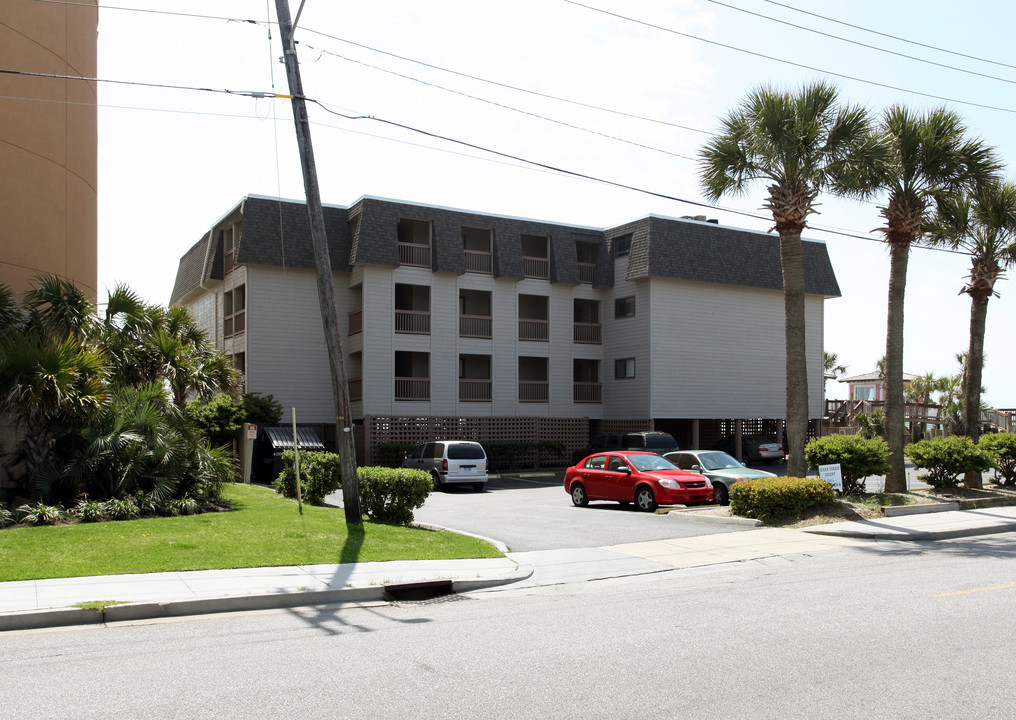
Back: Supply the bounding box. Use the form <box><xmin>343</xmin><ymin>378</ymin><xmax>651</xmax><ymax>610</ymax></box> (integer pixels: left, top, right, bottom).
<box><xmin>565</xmin><ymin>451</ymin><xmax>713</xmax><ymax>513</ymax></box>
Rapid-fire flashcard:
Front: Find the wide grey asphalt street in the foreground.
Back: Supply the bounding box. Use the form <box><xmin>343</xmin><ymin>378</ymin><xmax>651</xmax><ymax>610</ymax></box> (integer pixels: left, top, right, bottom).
<box><xmin>0</xmin><ymin>532</ymin><xmax>1016</xmax><ymax>720</ymax></box>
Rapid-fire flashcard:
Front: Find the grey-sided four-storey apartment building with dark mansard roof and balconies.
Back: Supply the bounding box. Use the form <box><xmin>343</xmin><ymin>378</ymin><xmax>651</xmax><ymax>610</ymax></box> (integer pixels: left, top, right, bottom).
<box><xmin>171</xmin><ymin>196</ymin><xmax>839</xmax><ymax>462</ymax></box>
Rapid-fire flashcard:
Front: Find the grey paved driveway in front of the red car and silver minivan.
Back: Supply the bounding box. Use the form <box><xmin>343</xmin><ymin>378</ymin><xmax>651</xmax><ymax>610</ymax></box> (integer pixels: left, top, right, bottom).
<box><xmin>404</xmin><ymin>472</ymin><xmax>745</xmax><ymax>552</ymax></box>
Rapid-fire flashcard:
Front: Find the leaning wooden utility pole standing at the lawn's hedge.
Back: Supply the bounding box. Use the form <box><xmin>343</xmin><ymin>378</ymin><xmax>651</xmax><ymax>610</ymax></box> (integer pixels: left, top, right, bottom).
<box><xmin>275</xmin><ymin>0</ymin><xmax>363</xmax><ymax>525</ymax></box>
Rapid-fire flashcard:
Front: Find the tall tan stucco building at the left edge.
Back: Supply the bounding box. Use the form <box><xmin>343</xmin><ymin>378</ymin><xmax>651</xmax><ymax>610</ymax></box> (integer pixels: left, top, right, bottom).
<box><xmin>0</xmin><ymin>0</ymin><xmax>99</xmax><ymax>300</ymax></box>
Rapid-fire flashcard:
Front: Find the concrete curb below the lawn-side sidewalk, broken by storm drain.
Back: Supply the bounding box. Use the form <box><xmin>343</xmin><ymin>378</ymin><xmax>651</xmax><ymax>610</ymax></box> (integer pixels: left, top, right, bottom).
<box><xmin>0</xmin><ymin>565</ymin><xmax>533</xmax><ymax>632</ymax></box>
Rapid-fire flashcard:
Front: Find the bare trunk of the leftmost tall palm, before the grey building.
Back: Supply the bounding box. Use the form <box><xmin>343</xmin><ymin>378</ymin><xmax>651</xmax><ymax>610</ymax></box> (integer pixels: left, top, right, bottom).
<box><xmin>779</xmin><ymin>233</ymin><xmax>808</xmax><ymax>477</ymax></box>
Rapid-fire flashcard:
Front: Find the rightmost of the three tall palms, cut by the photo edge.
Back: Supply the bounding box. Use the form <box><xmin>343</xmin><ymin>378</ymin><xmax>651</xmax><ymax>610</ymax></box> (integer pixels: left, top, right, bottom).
<box><xmin>929</xmin><ymin>176</ymin><xmax>1016</xmax><ymax>487</ymax></box>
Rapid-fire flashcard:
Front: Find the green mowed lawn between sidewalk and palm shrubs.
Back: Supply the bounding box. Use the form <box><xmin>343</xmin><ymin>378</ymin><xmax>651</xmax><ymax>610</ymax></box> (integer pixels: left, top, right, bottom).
<box><xmin>0</xmin><ymin>484</ymin><xmax>501</xmax><ymax>581</ymax></box>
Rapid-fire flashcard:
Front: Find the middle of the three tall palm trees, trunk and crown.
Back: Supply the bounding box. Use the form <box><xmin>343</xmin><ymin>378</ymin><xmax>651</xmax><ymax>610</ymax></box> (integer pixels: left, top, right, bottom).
<box><xmin>867</xmin><ymin>106</ymin><xmax>1000</xmax><ymax>493</ymax></box>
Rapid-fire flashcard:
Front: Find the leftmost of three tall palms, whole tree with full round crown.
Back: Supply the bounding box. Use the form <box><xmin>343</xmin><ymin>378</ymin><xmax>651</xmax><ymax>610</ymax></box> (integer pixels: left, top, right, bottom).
<box><xmin>699</xmin><ymin>82</ymin><xmax>882</xmax><ymax>476</ymax></box>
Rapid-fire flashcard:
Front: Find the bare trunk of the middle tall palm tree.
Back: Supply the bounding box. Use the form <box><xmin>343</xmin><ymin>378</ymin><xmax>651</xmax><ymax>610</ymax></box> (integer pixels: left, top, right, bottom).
<box><xmin>885</xmin><ymin>243</ymin><xmax>910</xmax><ymax>493</ymax></box>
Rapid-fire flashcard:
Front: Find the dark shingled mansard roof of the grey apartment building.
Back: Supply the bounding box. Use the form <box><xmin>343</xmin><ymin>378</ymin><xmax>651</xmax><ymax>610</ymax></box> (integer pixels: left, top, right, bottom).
<box><xmin>171</xmin><ymin>196</ymin><xmax>840</xmax><ymax>302</ymax></box>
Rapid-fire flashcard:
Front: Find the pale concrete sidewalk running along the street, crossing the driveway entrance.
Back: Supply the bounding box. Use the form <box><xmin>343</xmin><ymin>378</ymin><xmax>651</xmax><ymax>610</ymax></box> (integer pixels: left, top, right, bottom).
<box><xmin>0</xmin><ymin>506</ymin><xmax>1016</xmax><ymax>631</ymax></box>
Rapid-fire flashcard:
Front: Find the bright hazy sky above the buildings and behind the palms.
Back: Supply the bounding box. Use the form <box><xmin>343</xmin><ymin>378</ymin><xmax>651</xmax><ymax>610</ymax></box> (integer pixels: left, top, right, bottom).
<box><xmin>91</xmin><ymin>0</ymin><xmax>1016</xmax><ymax>407</ymax></box>
